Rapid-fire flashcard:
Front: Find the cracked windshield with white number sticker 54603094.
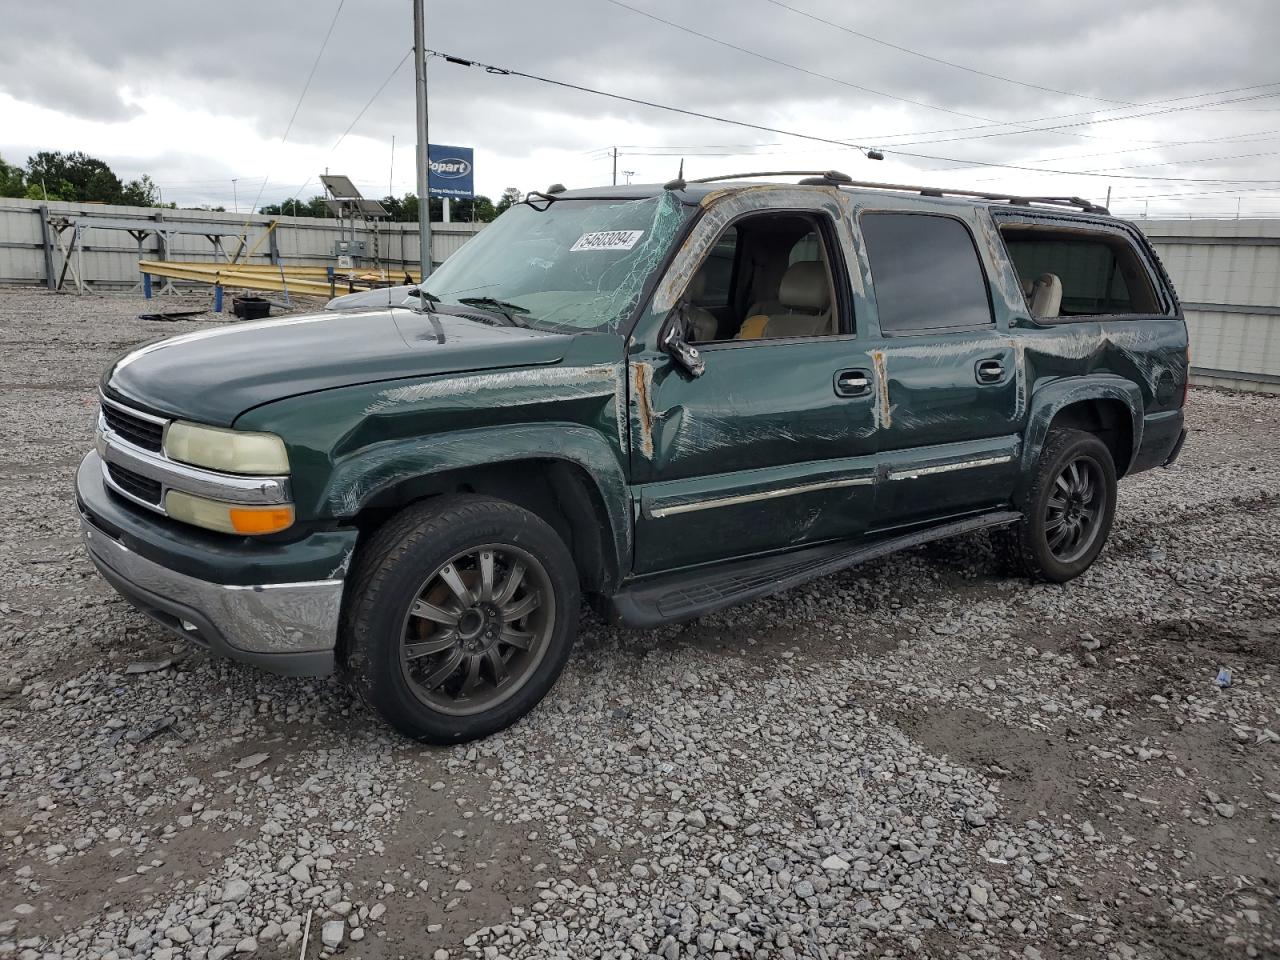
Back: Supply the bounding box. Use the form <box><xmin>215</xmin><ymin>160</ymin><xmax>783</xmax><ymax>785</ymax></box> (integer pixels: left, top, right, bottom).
<box><xmin>424</xmin><ymin>193</ymin><xmax>691</xmax><ymax>333</ymax></box>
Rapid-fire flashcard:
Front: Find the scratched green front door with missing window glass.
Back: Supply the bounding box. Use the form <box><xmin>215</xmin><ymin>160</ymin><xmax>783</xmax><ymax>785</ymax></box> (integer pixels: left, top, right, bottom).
<box><xmin>630</xmin><ymin>202</ymin><xmax>877</xmax><ymax>572</ymax></box>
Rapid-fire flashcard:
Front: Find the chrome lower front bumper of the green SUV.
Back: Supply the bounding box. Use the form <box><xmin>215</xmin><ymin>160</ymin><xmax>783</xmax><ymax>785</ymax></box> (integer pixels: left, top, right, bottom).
<box><xmin>81</xmin><ymin>512</ymin><xmax>343</xmax><ymax>676</ymax></box>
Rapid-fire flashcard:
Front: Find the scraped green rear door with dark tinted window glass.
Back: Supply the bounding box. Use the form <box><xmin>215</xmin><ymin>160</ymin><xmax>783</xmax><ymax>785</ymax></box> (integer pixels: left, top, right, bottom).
<box><xmin>859</xmin><ymin>206</ymin><xmax>1024</xmax><ymax>530</ymax></box>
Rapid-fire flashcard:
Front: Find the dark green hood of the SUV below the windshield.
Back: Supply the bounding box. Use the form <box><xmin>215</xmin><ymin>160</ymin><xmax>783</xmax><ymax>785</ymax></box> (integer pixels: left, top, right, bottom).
<box><xmin>102</xmin><ymin>310</ymin><xmax>570</xmax><ymax>426</ymax></box>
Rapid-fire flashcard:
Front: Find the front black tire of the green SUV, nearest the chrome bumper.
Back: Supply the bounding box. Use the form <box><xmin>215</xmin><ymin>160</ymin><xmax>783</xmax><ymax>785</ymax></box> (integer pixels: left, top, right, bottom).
<box><xmin>343</xmin><ymin>494</ymin><xmax>580</xmax><ymax>744</ymax></box>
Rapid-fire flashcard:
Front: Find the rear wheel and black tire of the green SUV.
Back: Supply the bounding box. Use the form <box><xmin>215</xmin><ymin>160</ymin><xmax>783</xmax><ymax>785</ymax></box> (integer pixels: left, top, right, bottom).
<box><xmin>993</xmin><ymin>428</ymin><xmax>1116</xmax><ymax>584</ymax></box>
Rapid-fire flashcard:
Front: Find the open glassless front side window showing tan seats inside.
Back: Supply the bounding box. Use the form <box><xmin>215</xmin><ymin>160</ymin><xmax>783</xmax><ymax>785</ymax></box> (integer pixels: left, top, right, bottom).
<box><xmin>685</xmin><ymin>214</ymin><xmax>846</xmax><ymax>343</ymax></box>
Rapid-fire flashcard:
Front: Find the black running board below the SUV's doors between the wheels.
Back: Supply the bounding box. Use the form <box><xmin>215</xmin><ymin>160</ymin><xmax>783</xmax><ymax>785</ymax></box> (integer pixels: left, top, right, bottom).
<box><xmin>605</xmin><ymin>511</ymin><xmax>1023</xmax><ymax>627</ymax></box>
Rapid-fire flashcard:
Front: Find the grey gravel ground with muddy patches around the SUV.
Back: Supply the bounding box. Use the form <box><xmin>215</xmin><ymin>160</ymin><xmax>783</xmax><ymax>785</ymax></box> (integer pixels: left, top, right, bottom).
<box><xmin>0</xmin><ymin>291</ymin><xmax>1280</xmax><ymax>960</ymax></box>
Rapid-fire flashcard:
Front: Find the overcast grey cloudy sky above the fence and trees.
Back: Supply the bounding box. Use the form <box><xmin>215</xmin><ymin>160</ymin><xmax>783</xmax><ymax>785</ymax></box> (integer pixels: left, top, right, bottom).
<box><xmin>0</xmin><ymin>0</ymin><xmax>1280</xmax><ymax>216</ymax></box>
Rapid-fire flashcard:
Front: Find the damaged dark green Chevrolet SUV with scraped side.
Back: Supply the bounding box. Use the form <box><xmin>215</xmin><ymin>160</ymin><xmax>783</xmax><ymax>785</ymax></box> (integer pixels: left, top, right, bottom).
<box><xmin>77</xmin><ymin>172</ymin><xmax>1188</xmax><ymax>742</ymax></box>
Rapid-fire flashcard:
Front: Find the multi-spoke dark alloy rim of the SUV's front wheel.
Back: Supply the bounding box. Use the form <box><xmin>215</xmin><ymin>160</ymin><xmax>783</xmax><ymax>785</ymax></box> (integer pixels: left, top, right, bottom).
<box><xmin>399</xmin><ymin>544</ymin><xmax>556</xmax><ymax>716</ymax></box>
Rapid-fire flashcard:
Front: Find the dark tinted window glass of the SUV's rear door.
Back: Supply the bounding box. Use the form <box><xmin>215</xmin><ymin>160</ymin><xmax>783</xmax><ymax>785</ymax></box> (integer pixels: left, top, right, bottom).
<box><xmin>859</xmin><ymin>214</ymin><xmax>992</xmax><ymax>333</ymax></box>
